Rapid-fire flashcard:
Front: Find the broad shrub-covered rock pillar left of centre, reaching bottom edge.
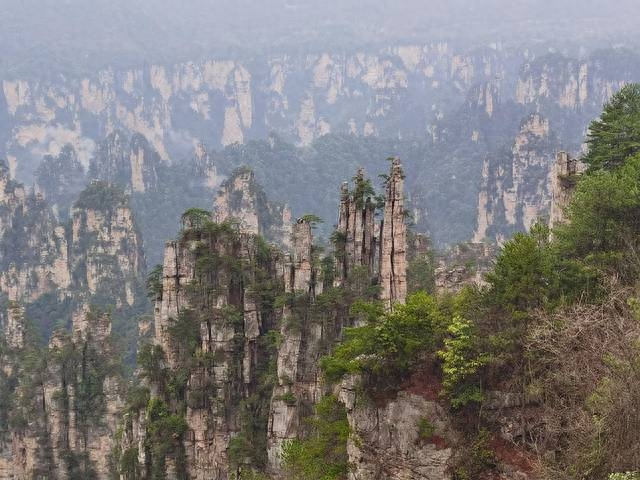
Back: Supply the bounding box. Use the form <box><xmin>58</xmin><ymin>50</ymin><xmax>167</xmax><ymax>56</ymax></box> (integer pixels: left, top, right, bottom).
<box><xmin>121</xmin><ymin>203</ymin><xmax>284</xmax><ymax>480</ymax></box>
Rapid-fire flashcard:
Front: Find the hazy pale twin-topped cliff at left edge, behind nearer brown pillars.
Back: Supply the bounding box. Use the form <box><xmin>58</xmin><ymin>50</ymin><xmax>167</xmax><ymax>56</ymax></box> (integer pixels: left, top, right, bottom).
<box><xmin>0</xmin><ymin>169</ymin><xmax>147</xmax><ymax>346</ymax></box>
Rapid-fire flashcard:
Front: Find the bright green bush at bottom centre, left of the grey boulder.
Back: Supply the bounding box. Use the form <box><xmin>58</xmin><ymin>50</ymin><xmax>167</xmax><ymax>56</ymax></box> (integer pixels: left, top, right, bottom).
<box><xmin>282</xmin><ymin>395</ymin><xmax>349</xmax><ymax>480</ymax></box>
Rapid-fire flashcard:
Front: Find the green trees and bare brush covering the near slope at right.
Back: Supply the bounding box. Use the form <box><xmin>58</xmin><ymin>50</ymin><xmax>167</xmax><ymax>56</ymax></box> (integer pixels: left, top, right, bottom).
<box><xmin>323</xmin><ymin>85</ymin><xmax>640</xmax><ymax>479</ymax></box>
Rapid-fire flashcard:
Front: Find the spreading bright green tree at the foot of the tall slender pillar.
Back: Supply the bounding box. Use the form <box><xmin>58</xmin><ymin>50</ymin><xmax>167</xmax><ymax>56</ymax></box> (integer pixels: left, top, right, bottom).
<box><xmin>321</xmin><ymin>293</ymin><xmax>446</xmax><ymax>383</ymax></box>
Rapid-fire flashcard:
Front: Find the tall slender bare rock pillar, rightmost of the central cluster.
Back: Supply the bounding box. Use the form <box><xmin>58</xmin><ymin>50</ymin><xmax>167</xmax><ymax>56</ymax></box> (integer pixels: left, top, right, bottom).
<box><xmin>380</xmin><ymin>158</ymin><xmax>407</xmax><ymax>309</ymax></box>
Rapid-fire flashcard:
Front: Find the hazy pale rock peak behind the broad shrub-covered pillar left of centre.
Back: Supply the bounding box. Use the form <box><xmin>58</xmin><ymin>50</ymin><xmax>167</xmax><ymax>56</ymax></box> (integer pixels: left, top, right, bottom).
<box><xmin>213</xmin><ymin>167</ymin><xmax>291</xmax><ymax>246</ymax></box>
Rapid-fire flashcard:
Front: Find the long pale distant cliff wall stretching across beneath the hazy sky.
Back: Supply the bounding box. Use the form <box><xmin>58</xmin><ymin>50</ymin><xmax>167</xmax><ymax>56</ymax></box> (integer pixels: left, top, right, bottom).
<box><xmin>0</xmin><ymin>42</ymin><xmax>640</xmax><ymax>184</ymax></box>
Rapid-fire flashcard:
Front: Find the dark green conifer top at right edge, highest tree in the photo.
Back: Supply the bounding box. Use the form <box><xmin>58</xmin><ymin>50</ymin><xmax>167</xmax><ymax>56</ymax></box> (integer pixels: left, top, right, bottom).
<box><xmin>583</xmin><ymin>83</ymin><xmax>640</xmax><ymax>170</ymax></box>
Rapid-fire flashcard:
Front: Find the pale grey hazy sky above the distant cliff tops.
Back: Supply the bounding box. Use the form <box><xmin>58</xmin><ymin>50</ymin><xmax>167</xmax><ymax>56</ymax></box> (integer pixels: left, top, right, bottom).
<box><xmin>0</xmin><ymin>0</ymin><xmax>640</xmax><ymax>74</ymax></box>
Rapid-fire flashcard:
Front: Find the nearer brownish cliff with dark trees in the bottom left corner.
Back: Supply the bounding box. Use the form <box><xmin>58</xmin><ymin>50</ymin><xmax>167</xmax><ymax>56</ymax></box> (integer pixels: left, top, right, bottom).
<box><xmin>0</xmin><ymin>310</ymin><xmax>123</xmax><ymax>480</ymax></box>
